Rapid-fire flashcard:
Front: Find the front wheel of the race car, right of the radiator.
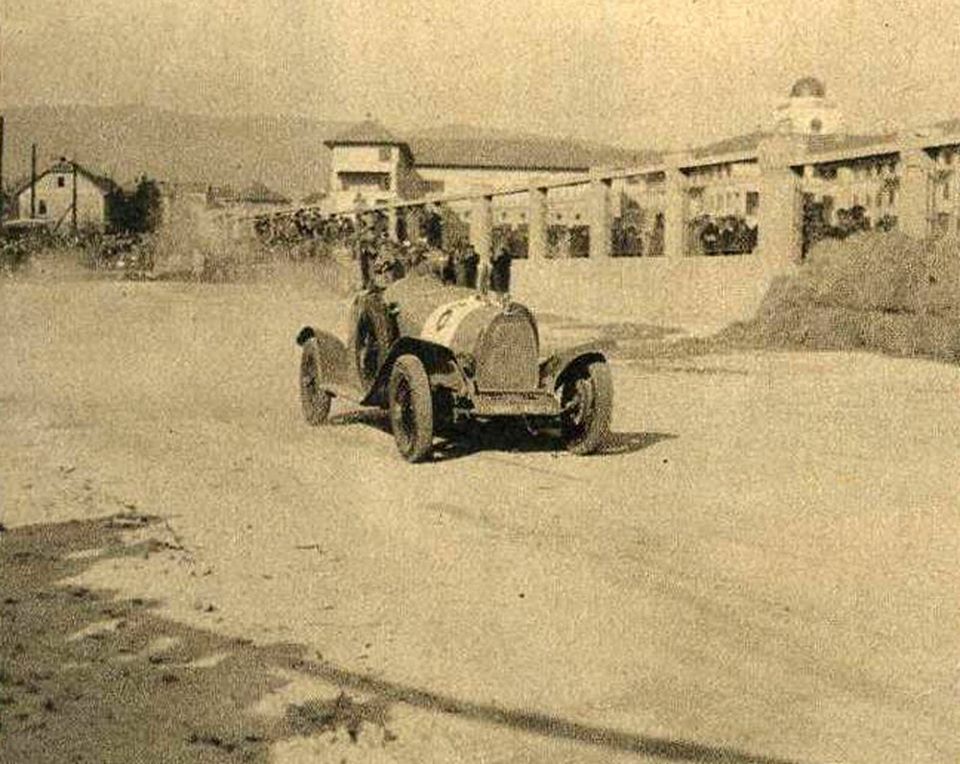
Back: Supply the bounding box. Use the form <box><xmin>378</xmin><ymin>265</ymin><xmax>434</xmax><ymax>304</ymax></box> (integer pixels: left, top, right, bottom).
<box><xmin>560</xmin><ymin>361</ymin><xmax>613</xmax><ymax>456</ymax></box>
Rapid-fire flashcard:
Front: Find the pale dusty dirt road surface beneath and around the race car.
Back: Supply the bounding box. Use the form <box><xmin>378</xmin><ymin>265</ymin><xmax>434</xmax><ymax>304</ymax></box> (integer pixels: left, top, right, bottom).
<box><xmin>0</xmin><ymin>283</ymin><xmax>960</xmax><ymax>763</ymax></box>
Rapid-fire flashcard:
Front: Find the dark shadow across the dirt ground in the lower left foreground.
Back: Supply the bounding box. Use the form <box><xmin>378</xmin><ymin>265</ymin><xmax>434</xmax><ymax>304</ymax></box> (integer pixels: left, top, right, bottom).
<box><xmin>0</xmin><ymin>515</ymin><xmax>808</xmax><ymax>764</ymax></box>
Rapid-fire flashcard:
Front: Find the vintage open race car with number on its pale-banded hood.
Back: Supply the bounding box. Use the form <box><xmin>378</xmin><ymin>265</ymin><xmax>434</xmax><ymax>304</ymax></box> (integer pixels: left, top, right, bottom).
<box><xmin>296</xmin><ymin>275</ymin><xmax>613</xmax><ymax>462</ymax></box>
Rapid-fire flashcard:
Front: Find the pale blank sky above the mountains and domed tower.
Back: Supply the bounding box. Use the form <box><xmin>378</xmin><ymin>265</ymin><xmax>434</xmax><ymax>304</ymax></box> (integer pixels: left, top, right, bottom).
<box><xmin>0</xmin><ymin>0</ymin><xmax>960</xmax><ymax>148</ymax></box>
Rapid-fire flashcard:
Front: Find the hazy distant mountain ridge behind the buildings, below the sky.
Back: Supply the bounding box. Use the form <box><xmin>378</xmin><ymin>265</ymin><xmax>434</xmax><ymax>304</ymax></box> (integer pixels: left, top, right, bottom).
<box><xmin>2</xmin><ymin>105</ymin><xmax>649</xmax><ymax>199</ymax></box>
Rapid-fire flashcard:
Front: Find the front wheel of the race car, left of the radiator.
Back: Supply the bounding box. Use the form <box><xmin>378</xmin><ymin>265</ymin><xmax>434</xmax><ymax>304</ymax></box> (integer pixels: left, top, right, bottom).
<box><xmin>389</xmin><ymin>355</ymin><xmax>433</xmax><ymax>462</ymax></box>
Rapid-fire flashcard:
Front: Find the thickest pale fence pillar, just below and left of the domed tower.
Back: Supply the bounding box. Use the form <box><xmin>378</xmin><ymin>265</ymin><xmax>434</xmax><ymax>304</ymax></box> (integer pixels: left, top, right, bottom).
<box><xmin>757</xmin><ymin>135</ymin><xmax>805</xmax><ymax>265</ymax></box>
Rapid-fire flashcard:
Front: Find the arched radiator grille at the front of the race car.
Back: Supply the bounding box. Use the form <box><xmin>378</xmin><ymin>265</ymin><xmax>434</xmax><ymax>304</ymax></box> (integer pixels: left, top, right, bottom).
<box><xmin>476</xmin><ymin>313</ymin><xmax>539</xmax><ymax>392</ymax></box>
